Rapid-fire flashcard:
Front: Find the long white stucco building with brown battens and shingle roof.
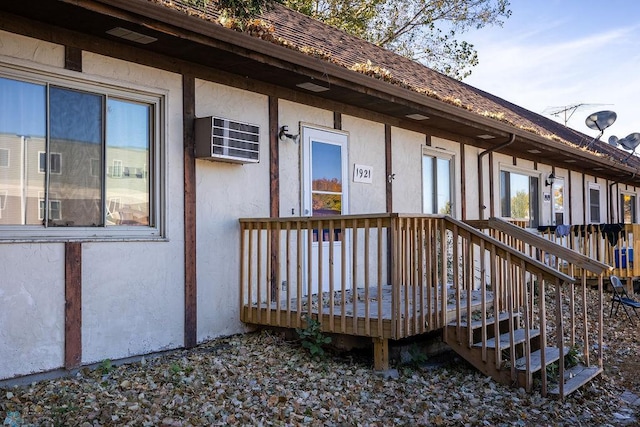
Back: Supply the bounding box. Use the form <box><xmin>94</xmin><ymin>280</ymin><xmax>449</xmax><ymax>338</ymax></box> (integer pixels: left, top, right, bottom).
<box><xmin>0</xmin><ymin>0</ymin><xmax>640</xmax><ymax>396</ymax></box>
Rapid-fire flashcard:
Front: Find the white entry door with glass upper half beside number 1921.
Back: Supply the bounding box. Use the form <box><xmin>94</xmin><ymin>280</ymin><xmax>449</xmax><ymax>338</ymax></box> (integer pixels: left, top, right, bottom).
<box><xmin>302</xmin><ymin>125</ymin><xmax>349</xmax><ymax>294</ymax></box>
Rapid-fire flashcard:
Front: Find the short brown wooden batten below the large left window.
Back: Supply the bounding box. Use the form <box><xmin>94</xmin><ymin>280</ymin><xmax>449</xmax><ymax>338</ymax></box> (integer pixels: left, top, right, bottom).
<box><xmin>64</xmin><ymin>242</ymin><xmax>82</xmax><ymax>369</ymax></box>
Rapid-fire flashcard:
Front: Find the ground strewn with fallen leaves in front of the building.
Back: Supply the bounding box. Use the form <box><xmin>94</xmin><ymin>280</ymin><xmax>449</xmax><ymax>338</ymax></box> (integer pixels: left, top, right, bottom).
<box><xmin>0</xmin><ymin>290</ymin><xmax>640</xmax><ymax>427</ymax></box>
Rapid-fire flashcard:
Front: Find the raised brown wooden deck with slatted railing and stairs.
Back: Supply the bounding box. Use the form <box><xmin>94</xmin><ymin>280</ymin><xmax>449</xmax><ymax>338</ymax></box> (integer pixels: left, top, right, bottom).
<box><xmin>239</xmin><ymin>214</ymin><xmax>609</xmax><ymax>397</ymax></box>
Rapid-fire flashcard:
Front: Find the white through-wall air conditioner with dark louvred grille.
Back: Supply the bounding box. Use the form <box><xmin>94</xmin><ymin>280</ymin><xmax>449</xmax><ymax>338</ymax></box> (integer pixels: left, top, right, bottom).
<box><xmin>196</xmin><ymin>117</ymin><xmax>260</xmax><ymax>163</ymax></box>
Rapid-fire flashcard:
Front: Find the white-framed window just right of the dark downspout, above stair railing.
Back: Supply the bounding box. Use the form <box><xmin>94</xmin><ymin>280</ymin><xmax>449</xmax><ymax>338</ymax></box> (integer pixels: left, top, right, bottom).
<box><xmin>500</xmin><ymin>170</ymin><xmax>540</xmax><ymax>228</ymax></box>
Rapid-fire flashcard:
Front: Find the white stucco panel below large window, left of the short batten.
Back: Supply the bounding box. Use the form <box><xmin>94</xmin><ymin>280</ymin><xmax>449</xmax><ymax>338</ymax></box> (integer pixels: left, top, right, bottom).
<box><xmin>0</xmin><ymin>244</ymin><xmax>64</xmax><ymax>379</ymax></box>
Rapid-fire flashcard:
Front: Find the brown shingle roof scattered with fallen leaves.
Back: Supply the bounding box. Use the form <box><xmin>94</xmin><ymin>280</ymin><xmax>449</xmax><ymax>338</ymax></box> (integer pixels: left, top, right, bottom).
<box><xmin>158</xmin><ymin>0</ymin><xmax>640</xmax><ymax>170</ymax></box>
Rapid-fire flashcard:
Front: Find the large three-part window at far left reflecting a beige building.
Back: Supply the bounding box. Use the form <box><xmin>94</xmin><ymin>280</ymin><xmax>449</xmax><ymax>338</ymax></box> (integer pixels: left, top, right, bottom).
<box><xmin>0</xmin><ymin>70</ymin><xmax>162</xmax><ymax>235</ymax></box>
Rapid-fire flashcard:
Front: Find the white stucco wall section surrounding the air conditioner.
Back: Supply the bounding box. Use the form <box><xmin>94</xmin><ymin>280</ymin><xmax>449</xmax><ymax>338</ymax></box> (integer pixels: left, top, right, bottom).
<box><xmin>196</xmin><ymin>80</ymin><xmax>272</xmax><ymax>341</ymax></box>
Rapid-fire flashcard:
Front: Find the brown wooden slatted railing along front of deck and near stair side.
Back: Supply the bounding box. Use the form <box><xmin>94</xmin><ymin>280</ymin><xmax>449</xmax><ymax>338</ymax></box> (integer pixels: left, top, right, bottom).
<box><xmin>240</xmin><ymin>214</ymin><xmax>602</xmax><ymax>387</ymax></box>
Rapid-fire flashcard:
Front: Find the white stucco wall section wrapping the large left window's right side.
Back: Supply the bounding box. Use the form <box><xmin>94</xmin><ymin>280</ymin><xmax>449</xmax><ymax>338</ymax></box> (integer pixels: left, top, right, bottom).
<box><xmin>82</xmin><ymin>52</ymin><xmax>184</xmax><ymax>363</ymax></box>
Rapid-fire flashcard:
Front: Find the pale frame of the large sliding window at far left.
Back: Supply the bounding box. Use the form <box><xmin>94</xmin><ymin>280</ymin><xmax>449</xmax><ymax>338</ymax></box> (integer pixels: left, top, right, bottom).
<box><xmin>0</xmin><ymin>62</ymin><xmax>169</xmax><ymax>242</ymax></box>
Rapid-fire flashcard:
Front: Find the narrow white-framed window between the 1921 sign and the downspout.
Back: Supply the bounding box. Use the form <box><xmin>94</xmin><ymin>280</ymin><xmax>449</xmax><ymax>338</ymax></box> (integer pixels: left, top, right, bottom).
<box><xmin>422</xmin><ymin>152</ymin><xmax>454</xmax><ymax>215</ymax></box>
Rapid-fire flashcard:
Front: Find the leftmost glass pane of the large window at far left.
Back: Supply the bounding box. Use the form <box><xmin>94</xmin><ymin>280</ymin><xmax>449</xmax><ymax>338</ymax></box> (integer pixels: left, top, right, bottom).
<box><xmin>0</xmin><ymin>78</ymin><xmax>47</xmax><ymax>225</ymax></box>
